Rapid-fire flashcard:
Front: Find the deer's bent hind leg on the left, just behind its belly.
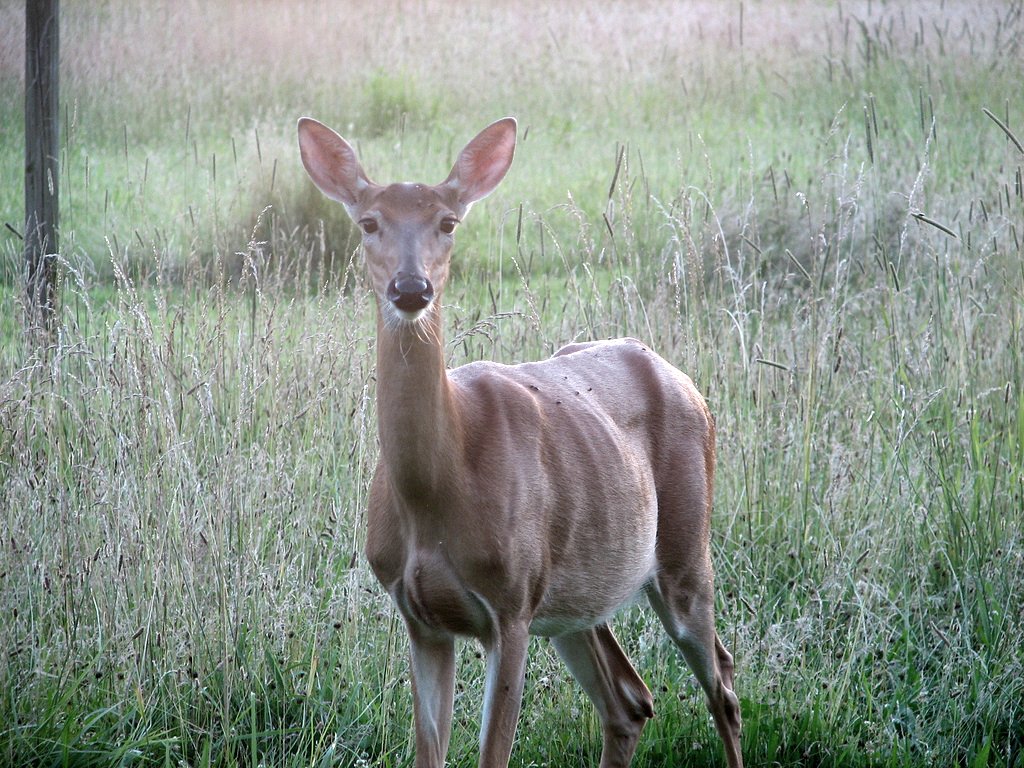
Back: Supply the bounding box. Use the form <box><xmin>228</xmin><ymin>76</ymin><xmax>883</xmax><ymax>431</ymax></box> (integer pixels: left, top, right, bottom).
<box><xmin>551</xmin><ymin>624</ymin><xmax>654</xmax><ymax>768</ymax></box>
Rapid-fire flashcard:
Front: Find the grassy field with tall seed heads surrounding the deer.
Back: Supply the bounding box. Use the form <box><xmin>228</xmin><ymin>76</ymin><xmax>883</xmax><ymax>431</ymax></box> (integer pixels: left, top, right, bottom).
<box><xmin>0</xmin><ymin>0</ymin><xmax>1024</xmax><ymax>768</ymax></box>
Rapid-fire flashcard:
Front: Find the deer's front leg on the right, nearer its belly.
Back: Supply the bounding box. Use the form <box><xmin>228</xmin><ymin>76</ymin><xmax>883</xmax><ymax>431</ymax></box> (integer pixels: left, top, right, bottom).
<box><xmin>480</xmin><ymin>624</ymin><xmax>529</xmax><ymax>768</ymax></box>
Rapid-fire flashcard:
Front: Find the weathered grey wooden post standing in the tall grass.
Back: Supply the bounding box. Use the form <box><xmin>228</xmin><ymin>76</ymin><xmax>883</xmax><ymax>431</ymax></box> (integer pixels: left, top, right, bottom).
<box><xmin>25</xmin><ymin>0</ymin><xmax>60</xmax><ymax>332</ymax></box>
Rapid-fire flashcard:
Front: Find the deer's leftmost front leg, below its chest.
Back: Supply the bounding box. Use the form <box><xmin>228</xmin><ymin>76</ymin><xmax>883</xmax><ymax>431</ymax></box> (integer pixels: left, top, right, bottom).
<box><xmin>406</xmin><ymin>620</ymin><xmax>455</xmax><ymax>768</ymax></box>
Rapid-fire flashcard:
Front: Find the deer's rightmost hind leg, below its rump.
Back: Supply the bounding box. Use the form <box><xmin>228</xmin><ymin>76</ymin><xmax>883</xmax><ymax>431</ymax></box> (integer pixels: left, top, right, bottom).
<box><xmin>647</xmin><ymin>581</ymin><xmax>743</xmax><ymax>768</ymax></box>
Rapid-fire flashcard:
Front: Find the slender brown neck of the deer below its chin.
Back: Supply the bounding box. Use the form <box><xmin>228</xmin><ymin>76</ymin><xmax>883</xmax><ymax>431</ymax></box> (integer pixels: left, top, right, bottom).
<box><xmin>377</xmin><ymin>302</ymin><xmax>461</xmax><ymax>509</ymax></box>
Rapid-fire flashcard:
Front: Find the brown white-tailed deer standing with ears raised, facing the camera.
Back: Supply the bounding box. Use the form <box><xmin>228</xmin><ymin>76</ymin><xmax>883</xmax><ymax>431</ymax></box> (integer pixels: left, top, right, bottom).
<box><xmin>298</xmin><ymin>118</ymin><xmax>742</xmax><ymax>768</ymax></box>
